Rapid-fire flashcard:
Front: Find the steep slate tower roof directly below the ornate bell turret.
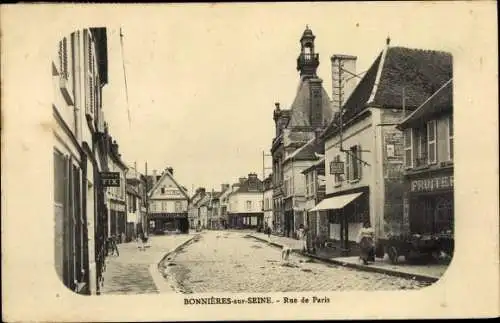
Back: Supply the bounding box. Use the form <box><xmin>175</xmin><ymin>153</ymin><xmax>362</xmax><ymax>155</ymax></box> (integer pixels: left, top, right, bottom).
<box><xmin>287</xmin><ymin>79</ymin><xmax>333</xmax><ymax>128</ymax></box>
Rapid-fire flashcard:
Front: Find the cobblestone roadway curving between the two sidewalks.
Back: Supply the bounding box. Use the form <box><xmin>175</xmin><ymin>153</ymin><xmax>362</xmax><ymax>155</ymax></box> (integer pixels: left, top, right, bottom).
<box><xmin>161</xmin><ymin>231</ymin><xmax>434</xmax><ymax>293</ymax></box>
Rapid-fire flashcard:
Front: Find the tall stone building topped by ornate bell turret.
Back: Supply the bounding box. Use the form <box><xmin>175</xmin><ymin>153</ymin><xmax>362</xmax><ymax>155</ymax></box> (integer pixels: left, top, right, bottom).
<box><xmin>271</xmin><ymin>27</ymin><xmax>333</xmax><ymax>236</ymax></box>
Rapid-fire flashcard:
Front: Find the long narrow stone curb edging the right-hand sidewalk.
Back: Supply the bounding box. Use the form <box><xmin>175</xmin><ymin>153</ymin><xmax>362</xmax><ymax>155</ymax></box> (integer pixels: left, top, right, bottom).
<box><xmin>248</xmin><ymin>235</ymin><xmax>439</xmax><ymax>283</ymax></box>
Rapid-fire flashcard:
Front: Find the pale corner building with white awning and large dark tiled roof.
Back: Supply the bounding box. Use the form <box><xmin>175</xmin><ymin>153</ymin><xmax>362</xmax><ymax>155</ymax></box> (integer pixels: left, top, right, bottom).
<box><xmin>316</xmin><ymin>40</ymin><xmax>452</xmax><ymax>255</ymax></box>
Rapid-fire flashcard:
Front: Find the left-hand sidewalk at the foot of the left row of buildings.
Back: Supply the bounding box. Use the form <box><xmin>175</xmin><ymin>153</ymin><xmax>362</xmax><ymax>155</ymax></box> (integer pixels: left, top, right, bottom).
<box><xmin>101</xmin><ymin>234</ymin><xmax>195</xmax><ymax>295</ymax></box>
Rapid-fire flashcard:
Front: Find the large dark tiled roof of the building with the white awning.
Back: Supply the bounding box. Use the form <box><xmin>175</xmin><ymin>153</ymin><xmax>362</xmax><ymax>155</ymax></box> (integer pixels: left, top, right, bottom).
<box><xmin>322</xmin><ymin>47</ymin><xmax>453</xmax><ymax>138</ymax></box>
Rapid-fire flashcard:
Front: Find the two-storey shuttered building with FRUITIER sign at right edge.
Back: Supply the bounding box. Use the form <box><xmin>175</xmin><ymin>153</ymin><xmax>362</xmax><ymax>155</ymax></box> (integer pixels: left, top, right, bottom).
<box><xmin>398</xmin><ymin>80</ymin><xmax>454</xmax><ymax>255</ymax></box>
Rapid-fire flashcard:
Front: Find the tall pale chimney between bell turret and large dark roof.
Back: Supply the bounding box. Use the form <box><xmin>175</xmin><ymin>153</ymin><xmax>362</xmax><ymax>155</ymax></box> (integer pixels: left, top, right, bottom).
<box><xmin>331</xmin><ymin>54</ymin><xmax>360</xmax><ymax>112</ymax></box>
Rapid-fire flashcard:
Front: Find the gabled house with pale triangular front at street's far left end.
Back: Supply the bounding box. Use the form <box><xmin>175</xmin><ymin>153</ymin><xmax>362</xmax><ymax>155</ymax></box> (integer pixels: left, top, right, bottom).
<box><xmin>148</xmin><ymin>167</ymin><xmax>189</xmax><ymax>234</ymax></box>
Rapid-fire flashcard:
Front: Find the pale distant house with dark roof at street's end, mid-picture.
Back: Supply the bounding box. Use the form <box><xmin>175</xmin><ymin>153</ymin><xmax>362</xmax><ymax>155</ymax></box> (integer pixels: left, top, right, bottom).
<box><xmin>228</xmin><ymin>173</ymin><xmax>264</xmax><ymax>229</ymax></box>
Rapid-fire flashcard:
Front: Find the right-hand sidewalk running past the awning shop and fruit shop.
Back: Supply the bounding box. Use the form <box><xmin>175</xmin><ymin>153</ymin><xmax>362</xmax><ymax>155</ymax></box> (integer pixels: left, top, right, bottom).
<box><xmin>249</xmin><ymin>232</ymin><xmax>448</xmax><ymax>282</ymax></box>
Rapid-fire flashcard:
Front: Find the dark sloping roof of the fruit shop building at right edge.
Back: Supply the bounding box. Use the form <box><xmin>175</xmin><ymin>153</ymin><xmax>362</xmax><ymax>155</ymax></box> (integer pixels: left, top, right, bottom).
<box><xmin>397</xmin><ymin>79</ymin><xmax>453</xmax><ymax>130</ymax></box>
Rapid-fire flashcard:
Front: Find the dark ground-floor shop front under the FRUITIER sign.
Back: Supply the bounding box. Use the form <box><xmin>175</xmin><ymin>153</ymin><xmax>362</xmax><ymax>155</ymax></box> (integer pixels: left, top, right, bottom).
<box><xmin>406</xmin><ymin>168</ymin><xmax>454</xmax><ymax>254</ymax></box>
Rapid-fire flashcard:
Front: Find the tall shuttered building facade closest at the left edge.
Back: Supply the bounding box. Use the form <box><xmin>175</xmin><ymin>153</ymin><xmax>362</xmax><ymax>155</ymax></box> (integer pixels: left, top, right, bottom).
<box><xmin>52</xmin><ymin>28</ymin><xmax>108</xmax><ymax>294</ymax></box>
